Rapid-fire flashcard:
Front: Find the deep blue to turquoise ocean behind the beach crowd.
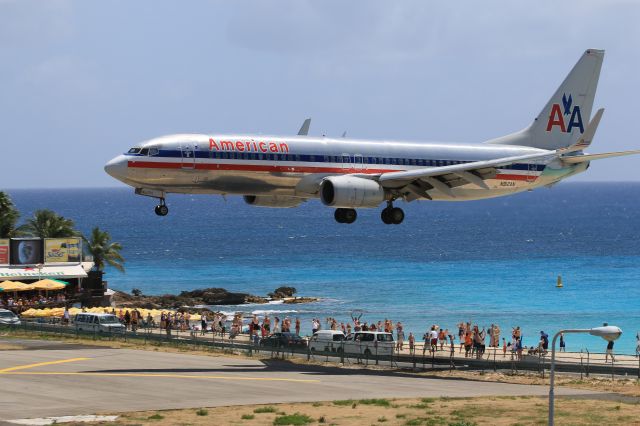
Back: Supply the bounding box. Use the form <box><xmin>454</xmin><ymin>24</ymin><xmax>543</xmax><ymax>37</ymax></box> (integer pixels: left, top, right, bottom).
<box><xmin>7</xmin><ymin>183</ymin><xmax>640</xmax><ymax>353</ymax></box>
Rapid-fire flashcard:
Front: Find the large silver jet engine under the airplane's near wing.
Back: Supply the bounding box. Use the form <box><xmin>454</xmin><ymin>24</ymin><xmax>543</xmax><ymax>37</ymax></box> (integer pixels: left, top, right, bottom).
<box><xmin>320</xmin><ymin>176</ymin><xmax>385</xmax><ymax>208</ymax></box>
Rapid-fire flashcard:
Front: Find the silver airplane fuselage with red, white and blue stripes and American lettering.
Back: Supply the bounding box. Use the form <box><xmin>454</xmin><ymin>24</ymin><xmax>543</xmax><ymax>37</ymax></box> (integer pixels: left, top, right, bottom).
<box><xmin>104</xmin><ymin>134</ymin><xmax>586</xmax><ymax>201</ymax></box>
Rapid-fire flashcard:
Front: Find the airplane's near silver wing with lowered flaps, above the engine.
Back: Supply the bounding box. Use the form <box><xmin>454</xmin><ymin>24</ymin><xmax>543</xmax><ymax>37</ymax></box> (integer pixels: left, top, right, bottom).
<box><xmin>377</xmin><ymin>151</ymin><xmax>557</xmax><ymax>199</ymax></box>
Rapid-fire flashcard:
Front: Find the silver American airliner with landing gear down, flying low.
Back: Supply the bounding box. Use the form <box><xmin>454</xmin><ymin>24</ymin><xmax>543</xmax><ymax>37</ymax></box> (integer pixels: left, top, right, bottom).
<box><xmin>105</xmin><ymin>49</ymin><xmax>640</xmax><ymax>224</ymax></box>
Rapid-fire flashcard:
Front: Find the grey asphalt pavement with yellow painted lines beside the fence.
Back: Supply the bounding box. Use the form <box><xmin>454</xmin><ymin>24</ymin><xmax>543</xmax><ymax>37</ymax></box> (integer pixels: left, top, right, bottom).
<box><xmin>0</xmin><ymin>339</ymin><xmax>594</xmax><ymax>420</ymax></box>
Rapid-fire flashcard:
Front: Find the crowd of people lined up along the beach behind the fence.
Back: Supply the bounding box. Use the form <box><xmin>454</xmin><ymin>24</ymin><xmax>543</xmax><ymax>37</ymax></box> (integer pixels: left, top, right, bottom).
<box><xmin>33</xmin><ymin>304</ymin><xmax>640</xmax><ymax>361</ymax></box>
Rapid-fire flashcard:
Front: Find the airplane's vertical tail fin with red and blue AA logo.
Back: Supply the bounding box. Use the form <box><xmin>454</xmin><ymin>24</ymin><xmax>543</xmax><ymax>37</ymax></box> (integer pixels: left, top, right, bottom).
<box><xmin>488</xmin><ymin>49</ymin><xmax>604</xmax><ymax>149</ymax></box>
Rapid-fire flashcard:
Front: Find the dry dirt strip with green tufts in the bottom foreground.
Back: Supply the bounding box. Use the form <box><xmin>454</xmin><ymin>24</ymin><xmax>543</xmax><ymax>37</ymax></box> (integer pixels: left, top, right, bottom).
<box><xmin>81</xmin><ymin>397</ymin><xmax>640</xmax><ymax>426</ymax></box>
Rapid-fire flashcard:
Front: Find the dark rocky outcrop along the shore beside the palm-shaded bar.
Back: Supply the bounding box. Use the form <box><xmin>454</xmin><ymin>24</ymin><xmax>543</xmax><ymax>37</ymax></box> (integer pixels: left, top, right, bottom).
<box><xmin>111</xmin><ymin>287</ymin><xmax>319</xmax><ymax>309</ymax></box>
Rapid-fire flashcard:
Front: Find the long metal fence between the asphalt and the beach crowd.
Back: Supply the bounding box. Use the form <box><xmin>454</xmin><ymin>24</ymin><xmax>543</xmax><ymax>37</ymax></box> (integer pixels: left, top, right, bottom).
<box><xmin>5</xmin><ymin>321</ymin><xmax>640</xmax><ymax>378</ymax></box>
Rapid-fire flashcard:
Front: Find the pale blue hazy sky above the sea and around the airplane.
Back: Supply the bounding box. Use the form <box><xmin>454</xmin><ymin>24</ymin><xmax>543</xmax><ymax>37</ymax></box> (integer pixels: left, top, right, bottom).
<box><xmin>0</xmin><ymin>0</ymin><xmax>640</xmax><ymax>188</ymax></box>
